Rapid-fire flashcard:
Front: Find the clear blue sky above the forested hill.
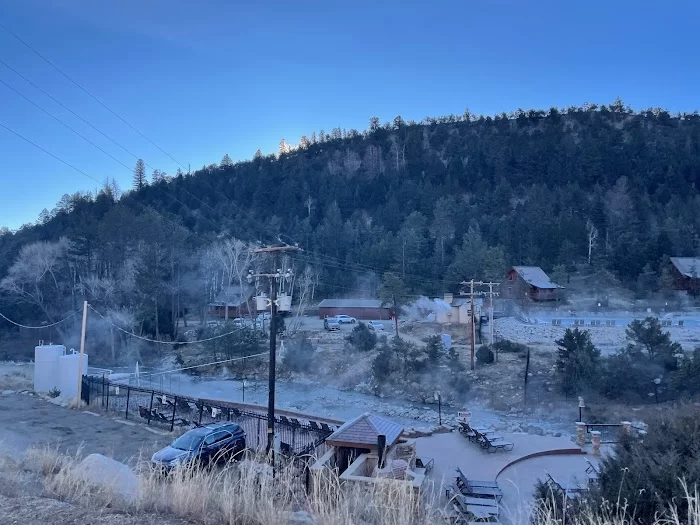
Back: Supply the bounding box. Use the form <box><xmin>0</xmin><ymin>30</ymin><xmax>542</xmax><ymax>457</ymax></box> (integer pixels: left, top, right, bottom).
<box><xmin>0</xmin><ymin>0</ymin><xmax>700</xmax><ymax>228</ymax></box>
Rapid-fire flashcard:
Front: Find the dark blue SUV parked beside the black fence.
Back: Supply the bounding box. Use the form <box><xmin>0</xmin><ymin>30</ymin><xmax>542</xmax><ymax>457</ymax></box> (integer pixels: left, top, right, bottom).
<box><xmin>151</xmin><ymin>423</ymin><xmax>245</xmax><ymax>472</ymax></box>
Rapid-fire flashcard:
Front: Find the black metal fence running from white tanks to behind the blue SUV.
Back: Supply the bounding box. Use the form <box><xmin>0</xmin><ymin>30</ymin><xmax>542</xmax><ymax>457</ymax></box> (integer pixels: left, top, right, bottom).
<box><xmin>82</xmin><ymin>376</ymin><xmax>335</xmax><ymax>457</ymax></box>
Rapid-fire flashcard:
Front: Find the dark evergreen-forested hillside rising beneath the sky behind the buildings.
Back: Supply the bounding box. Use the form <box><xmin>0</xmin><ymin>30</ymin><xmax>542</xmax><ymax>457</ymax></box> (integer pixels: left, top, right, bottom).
<box><xmin>0</xmin><ymin>101</ymin><xmax>700</xmax><ymax>342</ymax></box>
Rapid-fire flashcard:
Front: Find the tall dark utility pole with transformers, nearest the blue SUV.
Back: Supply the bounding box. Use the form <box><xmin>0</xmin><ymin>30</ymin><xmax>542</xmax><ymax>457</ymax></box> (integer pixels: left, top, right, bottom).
<box><xmin>248</xmin><ymin>244</ymin><xmax>301</xmax><ymax>476</ymax></box>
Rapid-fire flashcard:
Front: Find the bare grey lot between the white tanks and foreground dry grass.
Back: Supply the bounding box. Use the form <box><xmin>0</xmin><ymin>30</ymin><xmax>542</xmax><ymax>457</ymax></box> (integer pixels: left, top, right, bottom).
<box><xmin>0</xmin><ymin>394</ymin><xmax>172</xmax><ymax>462</ymax></box>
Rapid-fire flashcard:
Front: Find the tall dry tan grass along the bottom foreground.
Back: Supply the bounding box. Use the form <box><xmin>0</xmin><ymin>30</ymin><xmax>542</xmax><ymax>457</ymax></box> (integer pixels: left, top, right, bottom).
<box><xmin>0</xmin><ymin>448</ymin><xmax>700</xmax><ymax>525</ymax></box>
